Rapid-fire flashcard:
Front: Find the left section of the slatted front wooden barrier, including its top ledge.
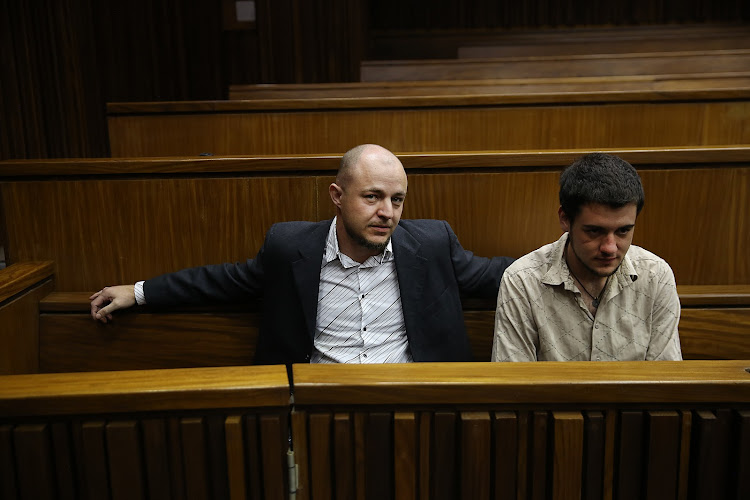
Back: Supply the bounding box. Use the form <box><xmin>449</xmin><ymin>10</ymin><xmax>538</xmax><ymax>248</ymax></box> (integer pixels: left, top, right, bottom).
<box><xmin>0</xmin><ymin>366</ymin><xmax>289</xmax><ymax>500</ymax></box>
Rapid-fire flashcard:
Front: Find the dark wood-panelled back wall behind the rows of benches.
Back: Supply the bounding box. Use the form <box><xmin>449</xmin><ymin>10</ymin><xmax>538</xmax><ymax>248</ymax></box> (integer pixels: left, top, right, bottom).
<box><xmin>0</xmin><ymin>0</ymin><xmax>750</xmax><ymax>159</ymax></box>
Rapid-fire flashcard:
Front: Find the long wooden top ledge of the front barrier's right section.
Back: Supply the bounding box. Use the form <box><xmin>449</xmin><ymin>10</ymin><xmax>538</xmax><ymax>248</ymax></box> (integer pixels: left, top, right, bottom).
<box><xmin>293</xmin><ymin>360</ymin><xmax>750</xmax><ymax>406</ymax></box>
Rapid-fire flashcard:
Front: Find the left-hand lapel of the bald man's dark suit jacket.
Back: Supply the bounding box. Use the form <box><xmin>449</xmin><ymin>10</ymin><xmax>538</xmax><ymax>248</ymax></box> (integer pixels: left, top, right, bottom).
<box><xmin>292</xmin><ymin>221</ymin><xmax>331</xmax><ymax>339</ymax></box>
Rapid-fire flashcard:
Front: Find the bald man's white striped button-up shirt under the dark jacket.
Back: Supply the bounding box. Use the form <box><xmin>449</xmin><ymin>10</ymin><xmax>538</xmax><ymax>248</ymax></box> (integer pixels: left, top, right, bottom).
<box><xmin>310</xmin><ymin>219</ymin><xmax>412</xmax><ymax>363</ymax></box>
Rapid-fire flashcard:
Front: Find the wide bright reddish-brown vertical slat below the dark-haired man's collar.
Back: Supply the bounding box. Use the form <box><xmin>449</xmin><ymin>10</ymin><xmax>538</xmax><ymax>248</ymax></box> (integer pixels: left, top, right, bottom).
<box><xmin>551</xmin><ymin>411</ymin><xmax>584</xmax><ymax>500</ymax></box>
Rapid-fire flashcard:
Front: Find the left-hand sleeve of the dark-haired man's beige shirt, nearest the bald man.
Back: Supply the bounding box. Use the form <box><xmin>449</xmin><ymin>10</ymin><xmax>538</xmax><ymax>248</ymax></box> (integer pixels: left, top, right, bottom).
<box><xmin>492</xmin><ymin>273</ymin><xmax>539</xmax><ymax>361</ymax></box>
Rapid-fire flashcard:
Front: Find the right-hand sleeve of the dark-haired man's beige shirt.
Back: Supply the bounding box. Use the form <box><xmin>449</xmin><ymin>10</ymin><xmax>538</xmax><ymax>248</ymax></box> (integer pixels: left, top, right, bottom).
<box><xmin>646</xmin><ymin>262</ymin><xmax>682</xmax><ymax>361</ymax></box>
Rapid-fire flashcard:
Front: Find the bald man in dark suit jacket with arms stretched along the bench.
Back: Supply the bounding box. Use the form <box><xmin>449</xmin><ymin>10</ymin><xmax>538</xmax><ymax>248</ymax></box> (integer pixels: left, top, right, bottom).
<box><xmin>90</xmin><ymin>144</ymin><xmax>512</xmax><ymax>364</ymax></box>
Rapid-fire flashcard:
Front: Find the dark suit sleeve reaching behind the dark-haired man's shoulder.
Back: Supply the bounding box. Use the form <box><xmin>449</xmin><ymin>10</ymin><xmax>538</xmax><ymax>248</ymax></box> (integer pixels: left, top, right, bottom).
<box><xmin>443</xmin><ymin>221</ymin><xmax>514</xmax><ymax>299</ymax></box>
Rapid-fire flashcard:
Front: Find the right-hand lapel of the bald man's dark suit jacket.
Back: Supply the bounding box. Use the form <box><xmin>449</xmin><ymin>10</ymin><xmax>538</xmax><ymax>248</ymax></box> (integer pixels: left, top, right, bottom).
<box><xmin>391</xmin><ymin>226</ymin><xmax>427</xmax><ymax>337</ymax></box>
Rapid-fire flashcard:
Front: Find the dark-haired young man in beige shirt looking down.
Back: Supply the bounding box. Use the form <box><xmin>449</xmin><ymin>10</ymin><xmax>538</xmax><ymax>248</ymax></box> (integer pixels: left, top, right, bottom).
<box><xmin>492</xmin><ymin>153</ymin><xmax>682</xmax><ymax>361</ymax></box>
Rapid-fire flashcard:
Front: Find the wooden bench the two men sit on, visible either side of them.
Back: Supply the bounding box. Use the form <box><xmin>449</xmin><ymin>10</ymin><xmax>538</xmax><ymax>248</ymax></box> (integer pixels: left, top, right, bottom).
<box><xmin>0</xmin><ymin>263</ymin><xmax>750</xmax><ymax>374</ymax></box>
